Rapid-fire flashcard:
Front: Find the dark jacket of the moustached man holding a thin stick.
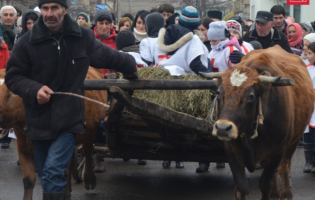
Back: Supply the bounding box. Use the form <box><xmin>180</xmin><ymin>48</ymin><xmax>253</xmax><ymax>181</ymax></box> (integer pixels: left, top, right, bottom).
<box><xmin>5</xmin><ymin>15</ymin><xmax>137</xmax><ymax>140</ymax></box>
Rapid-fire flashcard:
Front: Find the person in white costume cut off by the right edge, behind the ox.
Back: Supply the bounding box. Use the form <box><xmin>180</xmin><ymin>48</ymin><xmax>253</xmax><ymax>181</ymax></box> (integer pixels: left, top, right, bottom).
<box><xmin>303</xmin><ymin>42</ymin><xmax>315</xmax><ymax>174</ymax></box>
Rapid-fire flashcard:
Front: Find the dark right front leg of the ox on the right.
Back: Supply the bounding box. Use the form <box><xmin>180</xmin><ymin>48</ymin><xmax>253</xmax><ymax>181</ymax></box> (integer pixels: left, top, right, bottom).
<box><xmin>259</xmin><ymin>155</ymin><xmax>282</xmax><ymax>200</ymax></box>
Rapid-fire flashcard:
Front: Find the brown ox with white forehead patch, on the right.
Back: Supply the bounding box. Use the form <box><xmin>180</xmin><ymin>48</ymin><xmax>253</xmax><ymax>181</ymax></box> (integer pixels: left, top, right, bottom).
<box><xmin>202</xmin><ymin>46</ymin><xmax>314</xmax><ymax>200</ymax></box>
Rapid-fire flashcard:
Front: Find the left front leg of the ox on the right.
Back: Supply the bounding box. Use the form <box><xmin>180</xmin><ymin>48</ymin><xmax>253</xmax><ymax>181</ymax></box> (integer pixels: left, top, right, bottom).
<box><xmin>229</xmin><ymin>155</ymin><xmax>249</xmax><ymax>200</ymax></box>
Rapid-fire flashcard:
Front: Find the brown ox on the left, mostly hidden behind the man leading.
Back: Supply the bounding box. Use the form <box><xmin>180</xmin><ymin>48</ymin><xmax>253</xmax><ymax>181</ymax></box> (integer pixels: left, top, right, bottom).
<box><xmin>0</xmin><ymin>67</ymin><xmax>107</xmax><ymax>200</ymax></box>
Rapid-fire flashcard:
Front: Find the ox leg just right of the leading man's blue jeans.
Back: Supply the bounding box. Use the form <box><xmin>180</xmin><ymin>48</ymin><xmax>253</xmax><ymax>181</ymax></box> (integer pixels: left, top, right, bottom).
<box><xmin>83</xmin><ymin>142</ymin><xmax>96</xmax><ymax>190</ymax></box>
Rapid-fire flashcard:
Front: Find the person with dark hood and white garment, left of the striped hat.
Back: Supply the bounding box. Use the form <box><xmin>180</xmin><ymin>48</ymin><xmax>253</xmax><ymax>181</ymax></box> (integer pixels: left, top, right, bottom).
<box><xmin>139</xmin><ymin>13</ymin><xmax>165</xmax><ymax>66</ymax></box>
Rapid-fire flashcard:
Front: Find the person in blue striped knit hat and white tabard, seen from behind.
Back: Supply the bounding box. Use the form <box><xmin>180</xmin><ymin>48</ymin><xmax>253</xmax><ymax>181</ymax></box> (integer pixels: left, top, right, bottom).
<box><xmin>154</xmin><ymin>6</ymin><xmax>209</xmax><ymax>76</ymax></box>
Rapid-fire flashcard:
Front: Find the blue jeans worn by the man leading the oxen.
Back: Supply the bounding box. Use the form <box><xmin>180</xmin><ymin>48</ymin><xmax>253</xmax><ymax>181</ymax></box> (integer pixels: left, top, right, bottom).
<box><xmin>32</xmin><ymin>132</ymin><xmax>76</xmax><ymax>192</ymax></box>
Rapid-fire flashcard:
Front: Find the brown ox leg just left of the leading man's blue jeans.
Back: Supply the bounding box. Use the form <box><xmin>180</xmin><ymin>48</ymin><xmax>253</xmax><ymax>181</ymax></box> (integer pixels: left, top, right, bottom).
<box><xmin>15</xmin><ymin>135</ymin><xmax>36</xmax><ymax>200</ymax></box>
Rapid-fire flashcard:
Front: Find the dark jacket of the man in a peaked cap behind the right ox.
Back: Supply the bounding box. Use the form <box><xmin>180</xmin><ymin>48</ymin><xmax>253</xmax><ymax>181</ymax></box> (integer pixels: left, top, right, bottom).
<box><xmin>243</xmin><ymin>27</ymin><xmax>292</xmax><ymax>53</ymax></box>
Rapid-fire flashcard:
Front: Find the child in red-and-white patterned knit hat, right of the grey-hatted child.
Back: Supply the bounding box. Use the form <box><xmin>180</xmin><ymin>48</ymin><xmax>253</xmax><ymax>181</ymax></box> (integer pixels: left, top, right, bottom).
<box><xmin>226</xmin><ymin>20</ymin><xmax>254</xmax><ymax>55</ymax></box>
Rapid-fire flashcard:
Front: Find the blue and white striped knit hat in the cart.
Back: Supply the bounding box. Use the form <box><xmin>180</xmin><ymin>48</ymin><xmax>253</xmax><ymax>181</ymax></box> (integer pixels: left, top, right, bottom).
<box><xmin>179</xmin><ymin>6</ymin><xmax>200</xmax><ymax>29</ymax></box>
